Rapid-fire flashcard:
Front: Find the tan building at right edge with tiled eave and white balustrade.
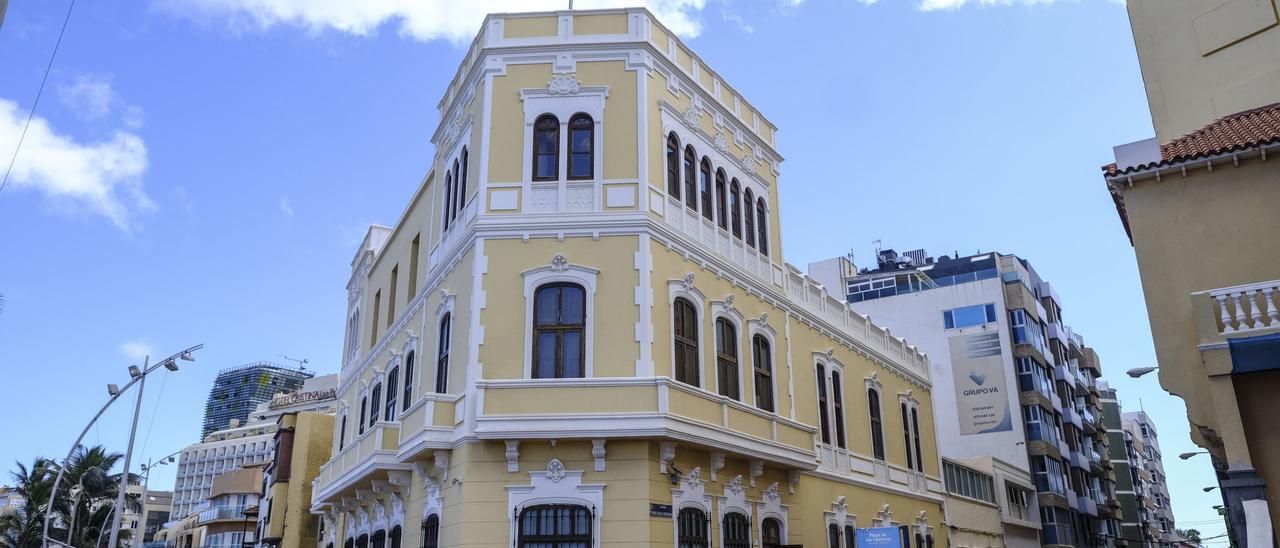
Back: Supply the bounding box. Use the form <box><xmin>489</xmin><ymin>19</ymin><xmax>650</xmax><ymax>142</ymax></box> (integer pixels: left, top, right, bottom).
<box><xmin>1103</xmin><ymin>0</ymin><xmax>1280</xmax><ymax>547</ymax></box>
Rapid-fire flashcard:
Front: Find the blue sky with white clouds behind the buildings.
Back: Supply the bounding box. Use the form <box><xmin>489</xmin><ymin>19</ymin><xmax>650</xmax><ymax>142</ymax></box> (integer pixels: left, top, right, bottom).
<box><xmin>0</xmin><ymin>0</ymin><xmax>1222</xmax><ymax>536</ymax></box>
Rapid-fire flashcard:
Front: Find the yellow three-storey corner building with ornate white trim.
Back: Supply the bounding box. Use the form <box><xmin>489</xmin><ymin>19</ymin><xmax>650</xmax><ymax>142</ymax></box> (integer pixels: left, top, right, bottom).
<box><xmin>312</xmin><ymin>9</ymin><xmax>943</xmax><ymax>548</ymax></box>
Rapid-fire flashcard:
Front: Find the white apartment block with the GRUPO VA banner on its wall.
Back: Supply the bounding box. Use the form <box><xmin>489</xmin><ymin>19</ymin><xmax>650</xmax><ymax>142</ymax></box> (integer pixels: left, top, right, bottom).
<box><xmin>809</xmin><ymin>250</ymin><xmax>1119</xmax><ymax>547</ymax></box>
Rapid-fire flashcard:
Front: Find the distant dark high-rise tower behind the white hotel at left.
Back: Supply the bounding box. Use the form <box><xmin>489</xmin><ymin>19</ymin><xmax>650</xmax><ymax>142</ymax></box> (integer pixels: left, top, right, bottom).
<box><xmin>200</xmin><ymin>361</ymin><xmax>315</xmax><ymax>439</ymax></box>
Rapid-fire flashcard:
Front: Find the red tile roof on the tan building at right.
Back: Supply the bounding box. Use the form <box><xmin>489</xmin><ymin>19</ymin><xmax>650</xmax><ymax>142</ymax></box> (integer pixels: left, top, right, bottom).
<box><xmin>1102</xmin><ymin>102</ymin><xmax>1280</xmax><ymax>175</ymax></box>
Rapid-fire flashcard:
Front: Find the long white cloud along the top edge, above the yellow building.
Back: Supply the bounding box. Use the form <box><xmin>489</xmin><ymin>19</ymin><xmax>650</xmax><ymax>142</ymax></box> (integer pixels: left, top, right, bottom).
<box><xmin>154</xmin><ymin>0</ymin><xmax>705</xmax><ymax>44</ymax></box>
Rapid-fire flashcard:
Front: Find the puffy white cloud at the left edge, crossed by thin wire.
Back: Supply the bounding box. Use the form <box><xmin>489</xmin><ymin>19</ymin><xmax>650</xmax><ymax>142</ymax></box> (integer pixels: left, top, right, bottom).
<box><xmin>0</xmin><ymin>99</ymin><xmax>155</xmax><ymax>232</ymax></box>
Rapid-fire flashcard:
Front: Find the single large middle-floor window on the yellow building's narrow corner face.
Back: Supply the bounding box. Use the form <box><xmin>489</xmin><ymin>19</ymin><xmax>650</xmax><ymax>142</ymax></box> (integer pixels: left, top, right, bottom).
<box><xmin>532</xmin><ymin>283</ymin><xmax>586</xmax><ymax>379</ymax></box>
